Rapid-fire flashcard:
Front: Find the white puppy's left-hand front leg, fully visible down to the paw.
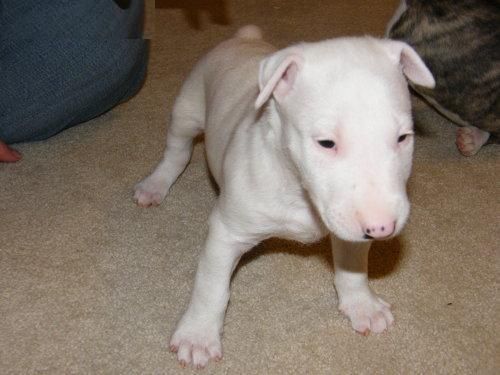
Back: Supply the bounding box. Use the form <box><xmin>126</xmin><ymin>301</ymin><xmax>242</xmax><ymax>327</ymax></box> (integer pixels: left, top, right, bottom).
<box><xmin>170</xmin><ymin>208</ymin><xmax>255</xmax><ymax>368</ymax></box>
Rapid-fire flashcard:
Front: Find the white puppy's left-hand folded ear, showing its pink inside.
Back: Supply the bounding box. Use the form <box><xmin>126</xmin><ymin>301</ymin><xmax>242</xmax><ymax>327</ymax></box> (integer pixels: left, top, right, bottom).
<box><xmin>255</xmin><ymin>47</ymin><xmax>303</xmax><ymax>109</ymax></box>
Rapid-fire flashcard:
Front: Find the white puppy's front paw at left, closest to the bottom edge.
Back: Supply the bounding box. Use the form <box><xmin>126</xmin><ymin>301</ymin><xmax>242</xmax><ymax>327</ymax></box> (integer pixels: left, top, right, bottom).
<box><xmin>170</xmin><ymin>321</ymin><xmax>222</xmax><ymax>369</ymax></box>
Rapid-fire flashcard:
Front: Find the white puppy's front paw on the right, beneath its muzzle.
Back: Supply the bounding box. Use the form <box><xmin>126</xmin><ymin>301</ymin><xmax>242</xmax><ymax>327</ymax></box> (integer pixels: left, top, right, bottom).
<box><xmin>339</xmin><ymin>293</ymin><xmax>394</xmax><ymax>336</ymax></box>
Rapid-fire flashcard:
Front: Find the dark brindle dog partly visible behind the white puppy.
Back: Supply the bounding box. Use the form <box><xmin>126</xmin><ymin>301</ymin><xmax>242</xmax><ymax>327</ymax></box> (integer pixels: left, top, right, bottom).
<box><xmin>387</xmin><ymin>0</ymin><xmax>500</xmax><ymax>156</ymax></box>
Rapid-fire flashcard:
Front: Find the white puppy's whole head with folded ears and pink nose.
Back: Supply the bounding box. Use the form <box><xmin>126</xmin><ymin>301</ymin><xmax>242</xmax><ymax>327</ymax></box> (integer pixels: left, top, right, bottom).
<box><xmin>256</xmin><ymin>37</ymin><xmax>434</xmax><ymax>241</ymax></box>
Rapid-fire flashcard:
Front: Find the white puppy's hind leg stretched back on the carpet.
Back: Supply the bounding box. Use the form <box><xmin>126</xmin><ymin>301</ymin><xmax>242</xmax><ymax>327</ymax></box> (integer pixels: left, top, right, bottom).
<box><xmin>134</xmin><ymin>72</ymin><xmax>205</xmax><ymax>207</ymax></box>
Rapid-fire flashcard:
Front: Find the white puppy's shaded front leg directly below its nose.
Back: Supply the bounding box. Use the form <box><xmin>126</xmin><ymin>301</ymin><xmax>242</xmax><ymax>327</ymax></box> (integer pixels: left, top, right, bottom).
<box><xmin>331</xmin><ymin>235</ymin><xmax>394</xmax><ymax>335</ymax></box>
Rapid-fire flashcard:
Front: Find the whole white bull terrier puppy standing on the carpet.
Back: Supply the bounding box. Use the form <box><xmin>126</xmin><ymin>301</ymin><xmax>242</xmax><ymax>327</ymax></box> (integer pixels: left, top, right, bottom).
<box><xmin>135</xmin><ymin>26</ymin><xmax>434</xmax><ymax>367</ymax></box>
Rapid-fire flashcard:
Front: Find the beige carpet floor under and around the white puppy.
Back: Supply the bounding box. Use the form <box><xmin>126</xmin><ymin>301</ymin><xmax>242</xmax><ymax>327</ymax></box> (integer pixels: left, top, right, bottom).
<box><xmin>0</xmin><ymin>0</ymin><xmax>500</xmax><ymax>374</ymax></box>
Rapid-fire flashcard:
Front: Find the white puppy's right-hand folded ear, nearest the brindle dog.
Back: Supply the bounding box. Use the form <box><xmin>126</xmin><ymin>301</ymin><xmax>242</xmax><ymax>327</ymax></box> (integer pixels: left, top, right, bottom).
<box><xmin>385</xmin><ymin>40</ymin><xmax>436</xmax><ymax>89</ymax></box>
